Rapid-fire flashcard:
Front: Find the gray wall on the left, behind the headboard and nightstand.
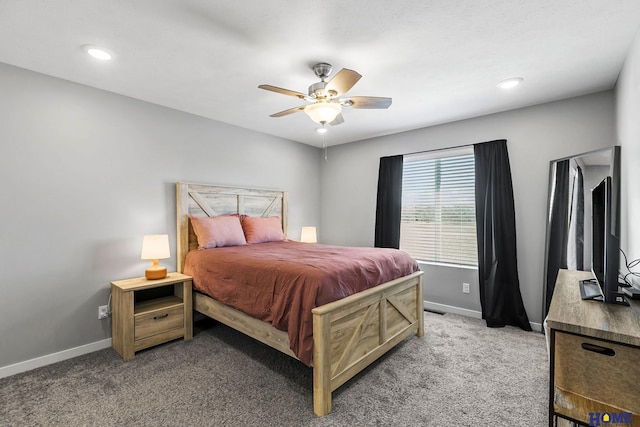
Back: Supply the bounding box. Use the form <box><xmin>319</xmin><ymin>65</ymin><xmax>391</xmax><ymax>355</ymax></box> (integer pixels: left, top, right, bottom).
<box><xmin>0</xmin><ymin>64</ymin><xmax>321</xmax><ymax>367</ymax></box>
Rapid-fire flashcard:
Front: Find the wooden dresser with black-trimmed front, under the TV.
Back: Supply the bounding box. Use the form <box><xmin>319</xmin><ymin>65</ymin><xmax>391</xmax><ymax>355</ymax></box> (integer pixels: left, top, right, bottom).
<box><xmin>546</xmin><ymin>270</ymin><xmax>640</xmax><ymax>426</ymax></box>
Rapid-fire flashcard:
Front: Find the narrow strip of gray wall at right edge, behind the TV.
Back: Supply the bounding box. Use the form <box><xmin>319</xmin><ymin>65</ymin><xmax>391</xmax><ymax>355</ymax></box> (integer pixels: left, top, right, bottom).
<box><xmin>616</xmin><ymin>29</ymin><xmax>640</xmax><ymax>278</ymax></box>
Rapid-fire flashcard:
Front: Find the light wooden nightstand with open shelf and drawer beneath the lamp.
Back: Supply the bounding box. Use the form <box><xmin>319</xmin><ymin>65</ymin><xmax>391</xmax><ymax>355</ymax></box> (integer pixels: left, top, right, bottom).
<box><xmin>111</xmin><ymin>273</ymin><xmax>193</xmax><ymax>360</ymax></box>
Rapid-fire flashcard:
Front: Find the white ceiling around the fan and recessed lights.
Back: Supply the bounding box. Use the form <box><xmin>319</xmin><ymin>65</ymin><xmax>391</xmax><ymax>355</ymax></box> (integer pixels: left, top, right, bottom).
<box><xmin>0</xmin><ymin>0</ymin><xmax>640</xmax><ymax>146</ymax></box>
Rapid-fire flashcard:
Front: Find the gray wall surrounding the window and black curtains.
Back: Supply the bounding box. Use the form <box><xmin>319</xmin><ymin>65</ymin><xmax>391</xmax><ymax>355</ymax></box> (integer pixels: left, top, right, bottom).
<box><xmin>320</xmin><ymin>91</ymin><xmax>615</xmax><ymax>323</ymax></box>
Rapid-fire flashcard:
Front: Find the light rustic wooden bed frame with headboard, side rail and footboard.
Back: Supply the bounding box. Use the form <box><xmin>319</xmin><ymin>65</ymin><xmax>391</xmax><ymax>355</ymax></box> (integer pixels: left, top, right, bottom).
<box><xmin>176</xmin><ymin>182</ymin><xmax>424</xmax><ymax>416</ymax></box>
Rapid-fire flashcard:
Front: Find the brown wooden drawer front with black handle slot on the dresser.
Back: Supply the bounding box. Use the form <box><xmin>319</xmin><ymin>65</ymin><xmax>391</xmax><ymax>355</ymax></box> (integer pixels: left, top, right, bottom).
<box><xmin>554</xmin><ymin>331</ymin><xmax>640</xmax><ymax>422</ymax></box>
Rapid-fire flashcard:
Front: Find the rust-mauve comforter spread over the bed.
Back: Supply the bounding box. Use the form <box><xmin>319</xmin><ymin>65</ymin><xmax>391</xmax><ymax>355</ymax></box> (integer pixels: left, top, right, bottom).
<box><xmin>184</xmin><ymin>241</ymin><xmax>418</xmax><ymax>365</ymax></box>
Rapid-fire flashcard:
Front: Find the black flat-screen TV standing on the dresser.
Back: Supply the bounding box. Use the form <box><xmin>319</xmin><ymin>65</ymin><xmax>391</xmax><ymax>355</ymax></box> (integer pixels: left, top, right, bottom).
<box><xmin>591</xmin><ymin>176</ymin><xmax>626</xmax><ymax>304</ymax></box>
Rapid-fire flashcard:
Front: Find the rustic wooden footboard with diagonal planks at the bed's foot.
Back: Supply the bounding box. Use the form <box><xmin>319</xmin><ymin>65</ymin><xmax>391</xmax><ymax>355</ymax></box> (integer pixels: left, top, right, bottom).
<box><xmin>312</xmin><ymin>271</ymin><xmax>424</xmax><ymax>416</ymax></box>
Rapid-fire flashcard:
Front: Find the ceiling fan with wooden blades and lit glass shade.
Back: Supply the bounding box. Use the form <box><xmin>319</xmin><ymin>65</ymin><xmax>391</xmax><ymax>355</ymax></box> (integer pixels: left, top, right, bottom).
<box><xmin>258</xmin><ymin>62</ymin><xmax>391</xmax><ymax>127</ymax></box>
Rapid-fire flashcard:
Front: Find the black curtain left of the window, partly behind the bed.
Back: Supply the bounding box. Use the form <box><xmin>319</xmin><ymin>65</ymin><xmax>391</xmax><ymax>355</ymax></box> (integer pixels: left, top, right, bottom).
<box><xmin>374</xmin><ymin>155</ymin><xmax>403</xmax><ymax>249</ymax></box>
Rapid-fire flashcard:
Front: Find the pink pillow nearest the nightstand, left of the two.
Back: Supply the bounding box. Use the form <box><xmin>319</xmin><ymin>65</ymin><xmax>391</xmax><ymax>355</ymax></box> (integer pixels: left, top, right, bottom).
<box><xmin>189</xmin><ymin>215</ymin><xmax>247</xmax><ymax>249</ymax></box>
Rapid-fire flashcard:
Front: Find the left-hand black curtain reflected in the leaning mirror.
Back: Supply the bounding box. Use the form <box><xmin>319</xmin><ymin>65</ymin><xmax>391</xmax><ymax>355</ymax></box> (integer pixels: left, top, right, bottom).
<box><xmin>543</xmin><ymin>160</ymin><xmax>568</xmax><ymax>317</ymax></box>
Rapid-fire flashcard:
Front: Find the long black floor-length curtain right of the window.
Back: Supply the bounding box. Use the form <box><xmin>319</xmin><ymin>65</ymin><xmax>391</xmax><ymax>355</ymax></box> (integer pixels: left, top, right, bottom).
<box><xmin>473</xmin><ymin>139</ymin><xmax>531</xmax><ymax>331</ymax></box>
